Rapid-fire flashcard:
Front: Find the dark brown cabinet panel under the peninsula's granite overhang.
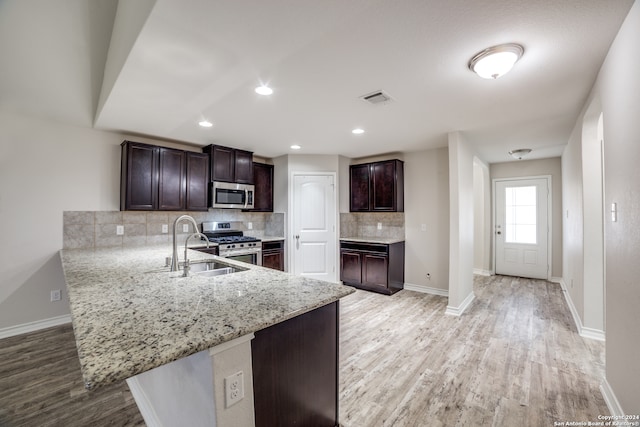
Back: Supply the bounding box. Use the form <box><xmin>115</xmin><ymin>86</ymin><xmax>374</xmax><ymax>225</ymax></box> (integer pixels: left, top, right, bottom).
<box><xmin>251</xmin><ymin>301</ymin><xmax>339</xmax><ymax>427</ymax></box>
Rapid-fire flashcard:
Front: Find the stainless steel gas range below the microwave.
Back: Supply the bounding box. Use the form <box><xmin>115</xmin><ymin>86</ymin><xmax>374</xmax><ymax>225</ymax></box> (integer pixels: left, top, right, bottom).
<box><xmin>202</xmin><ymin>222</ymin><xmax>262</xmax><ymax>265</ymax></box>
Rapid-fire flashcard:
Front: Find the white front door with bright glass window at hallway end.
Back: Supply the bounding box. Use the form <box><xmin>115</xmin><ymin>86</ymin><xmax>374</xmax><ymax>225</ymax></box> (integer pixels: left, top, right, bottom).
<box><xmin>494</xmin><ymin>177</ymin><xmax>550</xmax><ymax>279</ymax></box>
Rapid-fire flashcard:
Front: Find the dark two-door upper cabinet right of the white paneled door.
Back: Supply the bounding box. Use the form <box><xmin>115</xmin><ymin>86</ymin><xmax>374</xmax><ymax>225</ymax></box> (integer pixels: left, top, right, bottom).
<box><xmin>349</xmin><ymin>160</ymin><xmax>404</xmax><ymax>212</ymax></box>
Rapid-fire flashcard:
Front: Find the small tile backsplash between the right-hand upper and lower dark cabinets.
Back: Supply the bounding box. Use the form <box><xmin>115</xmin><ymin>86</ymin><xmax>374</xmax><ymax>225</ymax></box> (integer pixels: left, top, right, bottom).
<box><xmin>340</xmin><ymin>212</ymin><xmax>404</xmax><ymax>239</ymax></box>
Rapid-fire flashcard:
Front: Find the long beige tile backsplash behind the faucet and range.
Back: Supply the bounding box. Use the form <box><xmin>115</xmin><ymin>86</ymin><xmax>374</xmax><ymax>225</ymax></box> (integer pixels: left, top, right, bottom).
<box><xmin>63</xmin><ymin>209</ymin><xmax>284</xmax><ymax>249</ymax></box>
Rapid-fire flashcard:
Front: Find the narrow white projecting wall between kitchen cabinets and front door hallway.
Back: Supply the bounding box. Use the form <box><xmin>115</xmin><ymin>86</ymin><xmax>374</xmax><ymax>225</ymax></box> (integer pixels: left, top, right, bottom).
<box><xmin>447</xmin><ymin>132</ymin><xmax>475</xmax><ymax>315</ymax></box>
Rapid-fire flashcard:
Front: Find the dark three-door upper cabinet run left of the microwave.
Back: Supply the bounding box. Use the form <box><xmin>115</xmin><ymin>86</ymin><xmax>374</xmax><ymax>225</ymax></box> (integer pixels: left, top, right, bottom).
<box><xmin>120</xmin><ymin>141</ymin><xmax>209</xmax><ymax>210</ymax></box>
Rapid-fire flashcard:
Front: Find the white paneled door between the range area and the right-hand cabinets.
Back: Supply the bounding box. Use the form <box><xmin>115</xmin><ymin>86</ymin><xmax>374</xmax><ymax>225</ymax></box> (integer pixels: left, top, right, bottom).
<box><xmin>292</xmin><ymin>174</ymin><xmax>336</xmax><ymax>282</ymax></box>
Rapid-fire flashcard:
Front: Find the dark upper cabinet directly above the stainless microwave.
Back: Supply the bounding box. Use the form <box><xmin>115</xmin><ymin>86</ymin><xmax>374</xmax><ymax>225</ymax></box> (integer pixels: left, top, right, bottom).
<box><xmin>202</xmin><ymin>145</ymin><xmax>253</xmax><ymax>184</ymax></box>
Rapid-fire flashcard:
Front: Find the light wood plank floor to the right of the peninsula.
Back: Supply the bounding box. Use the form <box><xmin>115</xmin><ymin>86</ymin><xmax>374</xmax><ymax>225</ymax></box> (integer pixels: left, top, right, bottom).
<box><xmin>340</xmin><ymin>276</ymin><xmax>608</xmax><ymax>427</ymax></box>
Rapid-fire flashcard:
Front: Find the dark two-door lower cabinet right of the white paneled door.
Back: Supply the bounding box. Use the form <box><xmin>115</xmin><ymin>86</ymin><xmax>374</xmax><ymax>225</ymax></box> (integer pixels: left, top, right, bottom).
<box><xmin>340</xmin><ymin>241</ymin><xmax>404</xmax><ymax>295</ymax></box>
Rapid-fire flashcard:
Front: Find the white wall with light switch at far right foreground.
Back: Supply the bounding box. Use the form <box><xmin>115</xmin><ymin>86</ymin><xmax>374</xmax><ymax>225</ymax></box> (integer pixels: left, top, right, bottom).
<box><xmin>594</xmin><ymin>2</ymin><xmax>640</xmax><ymax>414</ymax></box>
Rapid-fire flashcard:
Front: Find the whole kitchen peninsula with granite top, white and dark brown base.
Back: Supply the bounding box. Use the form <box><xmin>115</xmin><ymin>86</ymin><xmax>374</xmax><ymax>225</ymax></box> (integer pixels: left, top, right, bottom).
<box><xmin>60</xmin><ymin>246</ymin><xmax>354</xmax><ymax>426</ymax></box>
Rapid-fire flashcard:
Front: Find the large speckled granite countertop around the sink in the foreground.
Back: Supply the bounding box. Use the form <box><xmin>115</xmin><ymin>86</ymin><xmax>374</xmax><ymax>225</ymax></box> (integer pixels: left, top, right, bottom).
<box><xmin>60</xmin><ymin>246</ymin><xmax>355</xmax><ymax>389</ymax></box>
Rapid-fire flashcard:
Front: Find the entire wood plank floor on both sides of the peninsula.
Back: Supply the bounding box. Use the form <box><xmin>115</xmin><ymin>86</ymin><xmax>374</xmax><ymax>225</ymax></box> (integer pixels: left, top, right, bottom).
<box><xmin>0</xmin><ymin>276</ymin><xmax>608</xmax><ymax>427</ymax></box>
